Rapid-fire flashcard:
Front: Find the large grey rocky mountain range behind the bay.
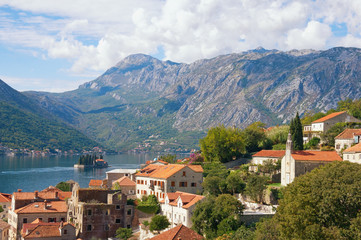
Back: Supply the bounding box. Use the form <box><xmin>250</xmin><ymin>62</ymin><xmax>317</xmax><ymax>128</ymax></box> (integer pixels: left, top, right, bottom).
<box><xmin>26</xmin><ymin>47</ymin><xmax>361</xmax><ymax>149</ymax></box>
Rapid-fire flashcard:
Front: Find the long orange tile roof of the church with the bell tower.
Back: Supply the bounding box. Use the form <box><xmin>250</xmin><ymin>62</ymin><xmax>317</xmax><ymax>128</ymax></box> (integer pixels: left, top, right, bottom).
<box><xmin>292</xmin><ymin>151</ymin><xmax>342</xmax><ymax>162</ymax></box>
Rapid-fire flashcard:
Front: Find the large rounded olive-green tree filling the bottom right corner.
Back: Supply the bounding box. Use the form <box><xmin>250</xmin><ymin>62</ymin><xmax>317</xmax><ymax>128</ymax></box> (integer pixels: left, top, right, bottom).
<box><xmin>275</xmin><ymin>161</ymin><xmax>361</xmax><ymax>239</ymax></box>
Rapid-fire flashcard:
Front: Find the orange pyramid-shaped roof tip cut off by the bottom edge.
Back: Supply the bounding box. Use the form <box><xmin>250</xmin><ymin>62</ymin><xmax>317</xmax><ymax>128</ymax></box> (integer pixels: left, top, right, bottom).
<box><xmin>151</xmin><ymin>224</ymin><xmax>204</xmax><ymax>240</ymax></box>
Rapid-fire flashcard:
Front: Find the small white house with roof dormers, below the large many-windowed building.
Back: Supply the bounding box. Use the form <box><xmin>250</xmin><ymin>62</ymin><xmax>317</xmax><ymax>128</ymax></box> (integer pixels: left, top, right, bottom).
<box><xmin>160</xmin><ymin>192</ymin><xmax>204</xmax><ymax>227</ymax></box>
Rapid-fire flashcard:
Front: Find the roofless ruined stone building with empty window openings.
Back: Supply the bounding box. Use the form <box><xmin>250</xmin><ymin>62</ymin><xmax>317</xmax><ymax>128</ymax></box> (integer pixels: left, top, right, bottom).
<box><xmin>67</xmin><ymin>184</ymin><xmax>134</xmax><ymax>239</ymax></box>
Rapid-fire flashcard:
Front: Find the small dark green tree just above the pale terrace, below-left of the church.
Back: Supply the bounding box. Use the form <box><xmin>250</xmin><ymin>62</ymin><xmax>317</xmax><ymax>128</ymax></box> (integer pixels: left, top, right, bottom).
<box><xmin>245</xmin><ymin>174</ymin><xmax>269</xmax><ymax>203</ymax></box>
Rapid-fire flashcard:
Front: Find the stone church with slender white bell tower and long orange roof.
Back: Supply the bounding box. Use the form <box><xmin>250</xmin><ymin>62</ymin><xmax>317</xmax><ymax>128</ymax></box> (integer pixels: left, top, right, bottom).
<box><xmin>281</xmin><ymin>133</ymin><xmax>342</xmax><ymax>186</ymax></box>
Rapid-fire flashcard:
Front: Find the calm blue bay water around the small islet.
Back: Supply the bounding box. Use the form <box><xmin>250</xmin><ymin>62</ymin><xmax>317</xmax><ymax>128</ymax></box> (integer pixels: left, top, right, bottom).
<box><xmin>0</xmin><ymin>154</ymin><xmax>157</xmax><ymax>193</ymax></box>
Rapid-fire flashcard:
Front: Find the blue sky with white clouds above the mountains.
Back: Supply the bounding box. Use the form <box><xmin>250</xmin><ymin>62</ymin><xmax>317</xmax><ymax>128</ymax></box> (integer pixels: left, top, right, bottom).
<box><xmin>0</xmin><ymin>0</ymin><xmax>361</xmax><ymax>92</ymax></box>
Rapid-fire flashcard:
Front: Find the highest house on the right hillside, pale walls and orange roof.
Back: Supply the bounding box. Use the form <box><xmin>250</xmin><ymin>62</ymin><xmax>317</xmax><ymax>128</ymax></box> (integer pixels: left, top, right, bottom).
<box><xmin>303</xmin><ymin>111</ymin><xmax>361</xmax><ymax>142</ymax></box>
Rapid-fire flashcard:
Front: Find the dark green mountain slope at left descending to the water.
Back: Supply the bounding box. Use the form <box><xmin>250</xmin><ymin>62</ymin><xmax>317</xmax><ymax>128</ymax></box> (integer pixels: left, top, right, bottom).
<box><xmin>0</xmin><ymin>80</ymin><xmax>100</xmax><ymax>150</ymax></box>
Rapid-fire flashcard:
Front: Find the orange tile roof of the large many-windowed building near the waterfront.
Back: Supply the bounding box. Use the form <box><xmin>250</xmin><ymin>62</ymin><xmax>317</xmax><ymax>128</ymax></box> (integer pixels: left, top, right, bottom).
<box><xmin>136</xmin><ymin>164</ymin><xmax>203</xmax><ymax>179</ymax></box>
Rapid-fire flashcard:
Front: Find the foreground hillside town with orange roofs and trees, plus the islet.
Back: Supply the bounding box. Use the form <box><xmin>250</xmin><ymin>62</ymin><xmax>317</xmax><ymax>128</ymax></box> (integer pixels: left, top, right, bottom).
<box><xmin>0</xmin><ymin>100</ymin><xmax>361</xmax><ymax>240</ymax></box>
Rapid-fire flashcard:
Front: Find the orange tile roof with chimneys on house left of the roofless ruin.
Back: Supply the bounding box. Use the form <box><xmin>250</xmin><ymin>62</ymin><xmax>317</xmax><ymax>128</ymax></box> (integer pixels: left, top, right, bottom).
<box><xmin>14</xmin><ymin>201</ymin><xmax>68</xmax><ymax>214</ymax></box>
